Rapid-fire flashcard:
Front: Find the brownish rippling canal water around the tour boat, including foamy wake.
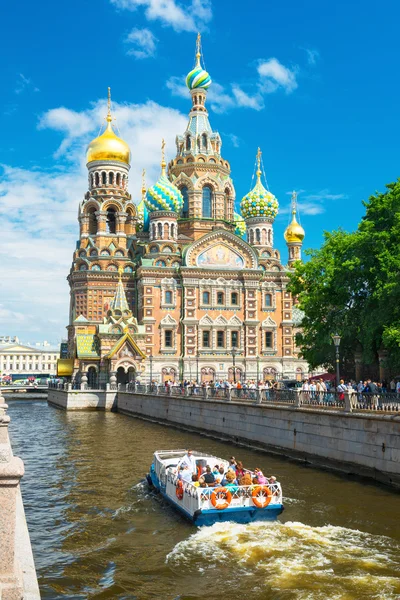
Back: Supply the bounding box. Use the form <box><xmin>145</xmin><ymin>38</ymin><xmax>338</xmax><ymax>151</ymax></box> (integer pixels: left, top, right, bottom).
<box><xmin>9</xmin><ymin>400</ymin><xmax>400</xmax><ymax>600</ymax></box>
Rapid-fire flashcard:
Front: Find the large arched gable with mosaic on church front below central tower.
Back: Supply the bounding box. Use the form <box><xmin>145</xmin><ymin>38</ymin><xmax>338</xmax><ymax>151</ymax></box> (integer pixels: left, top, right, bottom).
<box><xmin>185</xmin><ymin>229</ymin><xmax>258</xmax><ymax>268</ymax></box>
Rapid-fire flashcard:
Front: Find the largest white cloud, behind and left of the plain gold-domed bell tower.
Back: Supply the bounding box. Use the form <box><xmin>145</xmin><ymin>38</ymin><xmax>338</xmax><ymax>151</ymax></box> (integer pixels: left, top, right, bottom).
<box><xmin>0</xmin><ymin>101</ymin><xmax>187</xmax><ymax>342</ymax></box>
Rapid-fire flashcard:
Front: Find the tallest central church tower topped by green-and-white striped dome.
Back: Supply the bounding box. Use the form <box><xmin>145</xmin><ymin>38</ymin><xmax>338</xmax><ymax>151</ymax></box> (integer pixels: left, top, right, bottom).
<box><xmin>168</xmin><ymin>34</ymin><xmax>235</xmax><ymax>240</ymax></box>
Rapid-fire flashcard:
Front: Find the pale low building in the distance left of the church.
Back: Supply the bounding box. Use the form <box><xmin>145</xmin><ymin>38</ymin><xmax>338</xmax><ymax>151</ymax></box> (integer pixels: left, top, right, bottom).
<box><xmin>0</xmin><ymin>338</ymin><xmax>60</xmax><ymax>379</ymax></box>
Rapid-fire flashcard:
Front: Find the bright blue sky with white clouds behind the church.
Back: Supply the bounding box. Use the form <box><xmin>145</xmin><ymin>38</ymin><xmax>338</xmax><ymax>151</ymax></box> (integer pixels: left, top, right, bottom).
<box><xmin>0</xmin><ymin>0</ymin><xmax>400</xmax><ymax>343</ymax></box>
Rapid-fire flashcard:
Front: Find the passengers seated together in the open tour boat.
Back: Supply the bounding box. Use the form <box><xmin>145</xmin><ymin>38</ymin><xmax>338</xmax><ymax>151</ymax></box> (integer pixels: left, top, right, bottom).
<box><xmin>176</xmin><ymin>450</ymin><xmax>278</xmax><ymax>488</ymax></box>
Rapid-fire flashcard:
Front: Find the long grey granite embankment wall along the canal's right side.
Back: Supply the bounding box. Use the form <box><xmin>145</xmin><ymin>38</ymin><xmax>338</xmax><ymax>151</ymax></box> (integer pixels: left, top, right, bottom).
<box><xmin>117</xmin><ymin>391</ymin><xmax>400</xmax><ymax>489</ymax></box>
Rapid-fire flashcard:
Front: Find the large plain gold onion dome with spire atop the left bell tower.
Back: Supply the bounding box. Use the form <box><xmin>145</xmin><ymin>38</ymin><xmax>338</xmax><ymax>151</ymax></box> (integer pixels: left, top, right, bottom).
<box><xmin>86</xmin><ymin>88</ymin><xmax>131</xmax><ymax>165</ymax></box>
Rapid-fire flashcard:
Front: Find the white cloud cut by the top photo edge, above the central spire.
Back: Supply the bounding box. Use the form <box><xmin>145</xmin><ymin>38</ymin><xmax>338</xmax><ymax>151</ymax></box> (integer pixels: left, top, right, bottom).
<box><xmin>111</xmin><ymin>0</ymin><xmax>212</xmax><ymax>31</ymax></box>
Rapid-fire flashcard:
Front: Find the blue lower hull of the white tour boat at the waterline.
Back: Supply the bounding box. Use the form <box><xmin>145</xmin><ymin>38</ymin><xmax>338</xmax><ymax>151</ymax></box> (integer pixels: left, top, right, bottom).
<box><xmin>146</xmin><ymin>465</ymin><xmax>284</xmax><ymax>527</ymax></box>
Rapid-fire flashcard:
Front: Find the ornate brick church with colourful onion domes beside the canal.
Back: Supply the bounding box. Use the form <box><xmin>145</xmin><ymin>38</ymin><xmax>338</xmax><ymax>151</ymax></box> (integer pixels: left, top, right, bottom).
<box><xmin>59</xmin><ymin>39</ymin><xmax>308</xmax><ymax>383</ymax></box>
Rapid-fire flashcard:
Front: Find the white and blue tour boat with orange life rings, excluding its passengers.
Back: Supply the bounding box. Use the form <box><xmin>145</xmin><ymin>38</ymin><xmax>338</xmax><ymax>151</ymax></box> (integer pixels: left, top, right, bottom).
<box><xmin>147</xmin><ymin>450</ymin><xmax>284</xmax><ymax>526</ymax></box>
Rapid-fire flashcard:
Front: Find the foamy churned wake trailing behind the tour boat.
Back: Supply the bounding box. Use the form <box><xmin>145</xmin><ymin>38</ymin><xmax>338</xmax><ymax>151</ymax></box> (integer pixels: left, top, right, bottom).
<box><xmin>166</xmin><ymin>522</ymin><xmax>400</xmax><ymax>600</ymax></box>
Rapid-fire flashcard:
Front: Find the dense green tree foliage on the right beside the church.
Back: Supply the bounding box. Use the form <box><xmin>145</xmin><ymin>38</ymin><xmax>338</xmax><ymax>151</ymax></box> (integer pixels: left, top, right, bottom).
<box><xmin>290</xmin><ymin>180</ymin><xmax>400</xmax><ymax>372</ymax></box>
